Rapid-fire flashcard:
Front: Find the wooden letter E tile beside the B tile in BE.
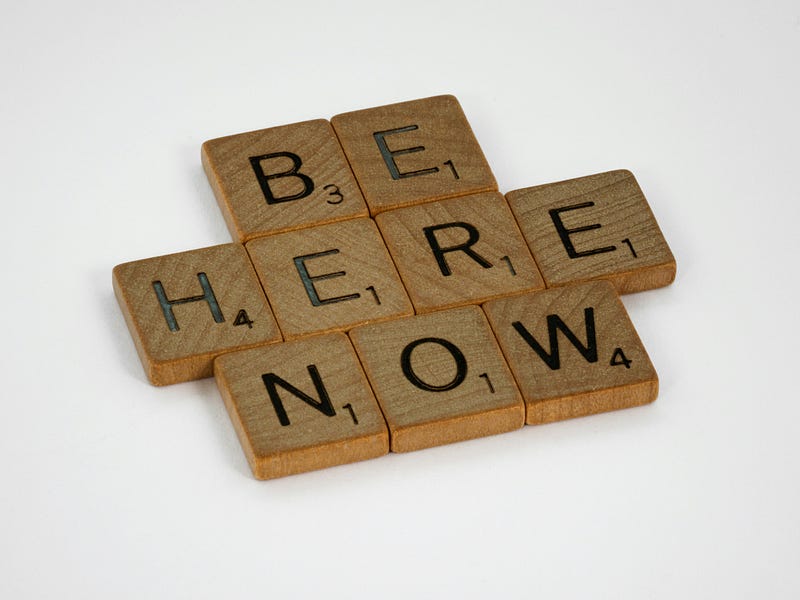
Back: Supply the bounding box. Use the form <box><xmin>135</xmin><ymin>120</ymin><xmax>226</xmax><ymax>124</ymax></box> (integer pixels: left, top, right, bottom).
<box><xmin>331</xmin><ymin>96</ymin><xmax>497</xmax><ymax>215</ymax></box>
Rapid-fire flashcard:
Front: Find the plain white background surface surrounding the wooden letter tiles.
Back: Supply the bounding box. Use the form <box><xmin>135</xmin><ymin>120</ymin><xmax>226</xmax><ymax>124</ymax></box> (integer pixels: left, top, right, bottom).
<box><xmin>0</xmin><ymin>0</ymin><xmax>800</xmax><ymax>600</ymax></box>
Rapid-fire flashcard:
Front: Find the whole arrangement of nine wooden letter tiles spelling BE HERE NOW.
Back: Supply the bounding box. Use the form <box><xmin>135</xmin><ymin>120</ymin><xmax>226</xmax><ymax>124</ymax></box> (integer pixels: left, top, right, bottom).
<box><xmin>113</xmin><ymin>96</ymin><xmax>676</xmax><ymax>479</ymax></box>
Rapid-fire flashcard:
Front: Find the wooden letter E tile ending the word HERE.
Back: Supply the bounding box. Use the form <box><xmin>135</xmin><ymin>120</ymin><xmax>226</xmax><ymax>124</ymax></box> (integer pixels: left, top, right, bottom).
<box><xmin>506</xmin><ymin>170</ymin><xmax>675</xmax><ymax>294</ymax></box>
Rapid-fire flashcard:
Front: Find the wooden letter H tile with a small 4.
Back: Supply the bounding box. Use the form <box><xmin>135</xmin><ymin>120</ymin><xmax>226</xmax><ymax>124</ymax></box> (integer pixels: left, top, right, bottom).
<box><xmin>113</xmin><ymin>244</ymin><xmax>281</xmax><ymax>385</ymax></box>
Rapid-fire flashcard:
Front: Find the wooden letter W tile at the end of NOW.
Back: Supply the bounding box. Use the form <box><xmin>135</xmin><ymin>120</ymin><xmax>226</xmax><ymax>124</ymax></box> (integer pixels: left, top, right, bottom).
<box><xmin>483</xmin><ymin>281</ymin><xmax>658</xmax><ymax>425</ymax></box>
